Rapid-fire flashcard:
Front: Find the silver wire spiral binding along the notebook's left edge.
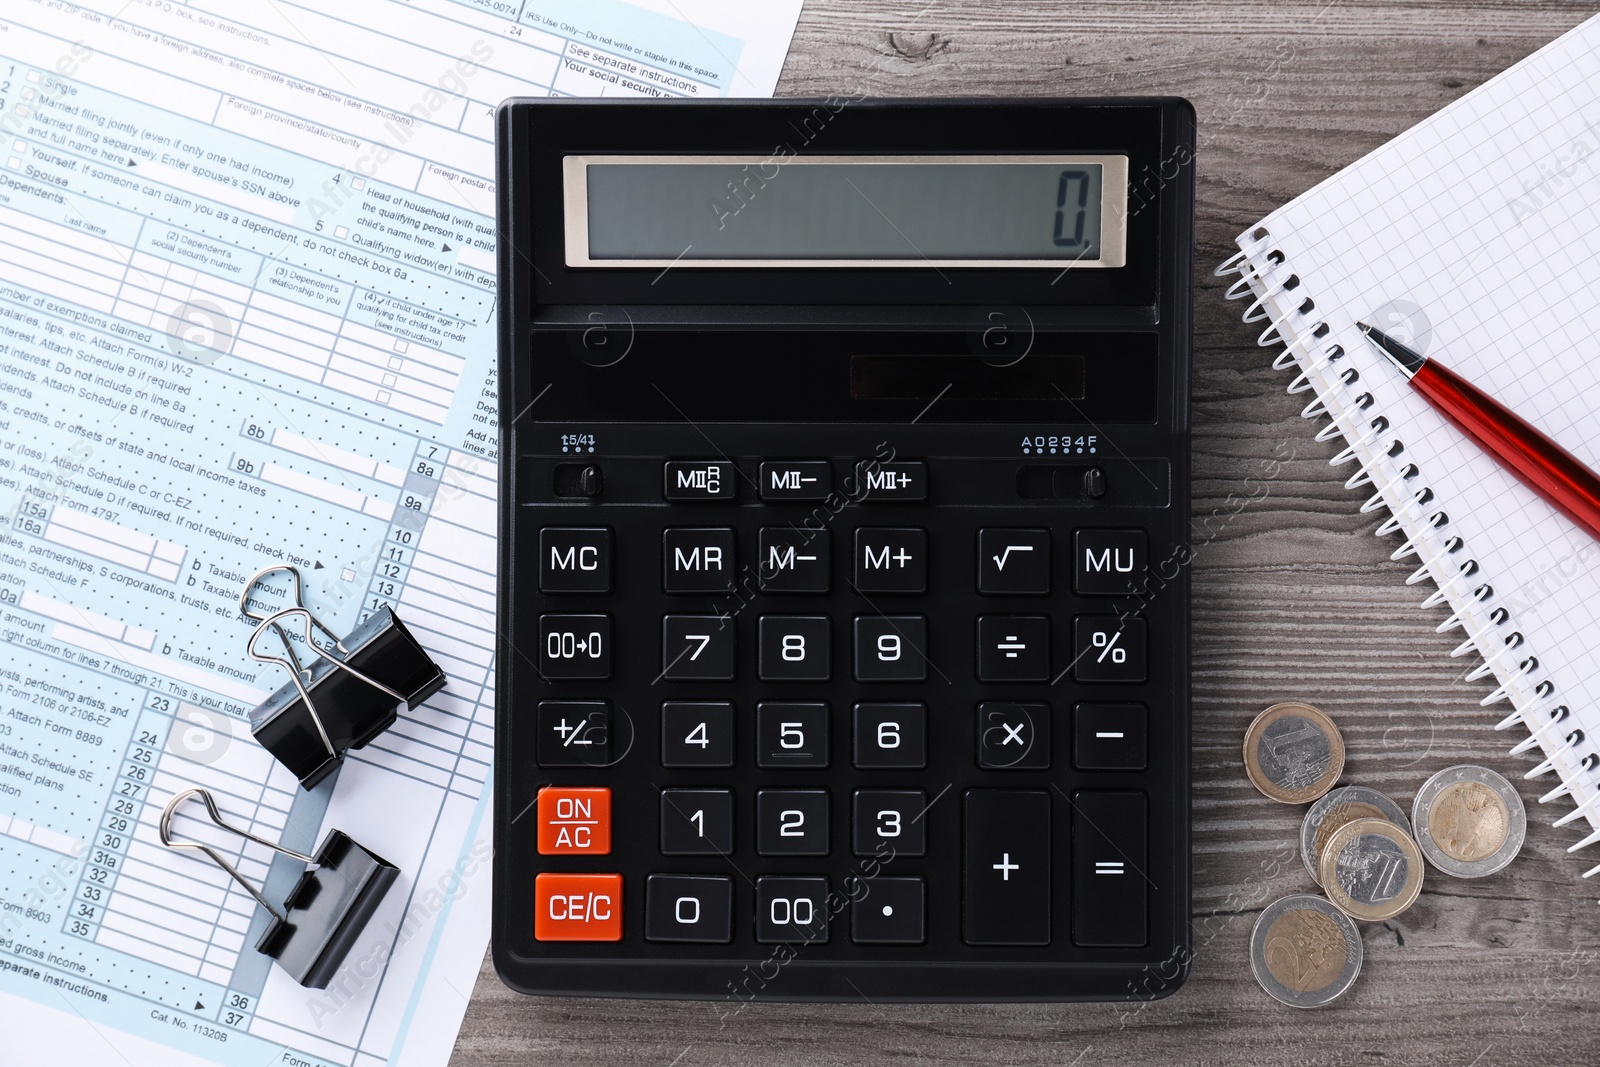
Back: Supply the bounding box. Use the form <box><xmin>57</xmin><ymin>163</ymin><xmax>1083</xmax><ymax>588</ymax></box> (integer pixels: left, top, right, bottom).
<box><xmin>1213</xmin><ymin>226</ymin><xmax>1600</xmax><ymax>878</ymax></box>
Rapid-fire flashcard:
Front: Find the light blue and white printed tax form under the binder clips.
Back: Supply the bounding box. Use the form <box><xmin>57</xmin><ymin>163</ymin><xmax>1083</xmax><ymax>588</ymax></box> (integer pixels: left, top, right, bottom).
<box><xmin>0</xmin><ymin>0</ymin><xmax>800</xmax><ymax>1067</ymax></box>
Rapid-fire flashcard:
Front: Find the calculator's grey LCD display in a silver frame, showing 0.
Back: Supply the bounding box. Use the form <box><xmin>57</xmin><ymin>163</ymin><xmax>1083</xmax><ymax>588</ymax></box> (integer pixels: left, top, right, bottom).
<box><xmin>563</xmin><ymin>155</ymin><xmax>1128</xmax><ymax>269</ymax></box>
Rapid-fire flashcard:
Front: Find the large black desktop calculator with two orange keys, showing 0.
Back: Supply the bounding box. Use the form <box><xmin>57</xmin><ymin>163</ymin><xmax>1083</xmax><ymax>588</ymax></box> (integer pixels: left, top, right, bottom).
<box><xmin>485</xmin><ymin>98</ymin><xmax>1195</xmax><ymax>1009</ymax></box>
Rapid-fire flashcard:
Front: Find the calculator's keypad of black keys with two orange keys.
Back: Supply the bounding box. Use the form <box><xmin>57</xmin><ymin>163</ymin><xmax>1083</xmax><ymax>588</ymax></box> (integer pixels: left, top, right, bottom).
<box><xmin>533</xmin><ymin>458</ymin><xmax>1160</xmax><ymax>958</ymax></box>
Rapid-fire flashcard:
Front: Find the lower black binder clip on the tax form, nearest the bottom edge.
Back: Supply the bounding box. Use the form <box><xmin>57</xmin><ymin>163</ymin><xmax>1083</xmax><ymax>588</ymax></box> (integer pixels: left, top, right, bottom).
<box><xmin>160</xmin><ymin>789</ymin><xmax>400</xmax><ymax>989</ymax></box>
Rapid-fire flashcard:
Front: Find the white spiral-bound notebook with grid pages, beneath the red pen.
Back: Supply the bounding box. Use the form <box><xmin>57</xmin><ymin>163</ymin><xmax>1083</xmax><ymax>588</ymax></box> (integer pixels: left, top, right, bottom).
<box><xmin>1218</xmin><ymin>16</ymin><xmax>1600</xmax><ymax>877</ymax></box>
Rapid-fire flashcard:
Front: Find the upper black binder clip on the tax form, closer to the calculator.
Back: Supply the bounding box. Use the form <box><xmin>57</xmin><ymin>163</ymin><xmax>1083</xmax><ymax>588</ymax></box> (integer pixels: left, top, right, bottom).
<box><xmin>238</xmin><ymin>563</ymin><xmax>445</xmax><ymax>789</ymax></box>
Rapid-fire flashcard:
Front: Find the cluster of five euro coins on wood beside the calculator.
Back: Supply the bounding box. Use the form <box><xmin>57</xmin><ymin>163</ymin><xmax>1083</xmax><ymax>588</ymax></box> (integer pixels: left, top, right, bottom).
<box><xmin>1245</xmin><ymin>701</ymin><xmax>1528</xmax><ymax>1008</ymax></box>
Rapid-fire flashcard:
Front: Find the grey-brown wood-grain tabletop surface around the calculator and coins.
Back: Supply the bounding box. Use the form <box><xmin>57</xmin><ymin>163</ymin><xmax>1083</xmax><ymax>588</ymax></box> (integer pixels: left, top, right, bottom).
<box><xmin>453</xmin><ymin>0</ymin><xmax>1600</xmax><ymax>1067</ymax></box>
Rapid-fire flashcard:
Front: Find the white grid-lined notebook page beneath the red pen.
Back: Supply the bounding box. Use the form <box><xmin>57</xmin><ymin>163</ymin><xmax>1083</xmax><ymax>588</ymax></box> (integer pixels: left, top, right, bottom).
<box><xmin>1240</xmin><ymin>18</ymin><xmax>1600</xmax><ymax>827</ymax></box>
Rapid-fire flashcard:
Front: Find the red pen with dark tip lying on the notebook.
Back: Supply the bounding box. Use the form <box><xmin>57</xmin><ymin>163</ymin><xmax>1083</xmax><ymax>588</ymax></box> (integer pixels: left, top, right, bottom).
<box><xmin>1357</xmin><ymin>323</ymin><xmax>1600</xmax><ymax>541</ymax></box>
